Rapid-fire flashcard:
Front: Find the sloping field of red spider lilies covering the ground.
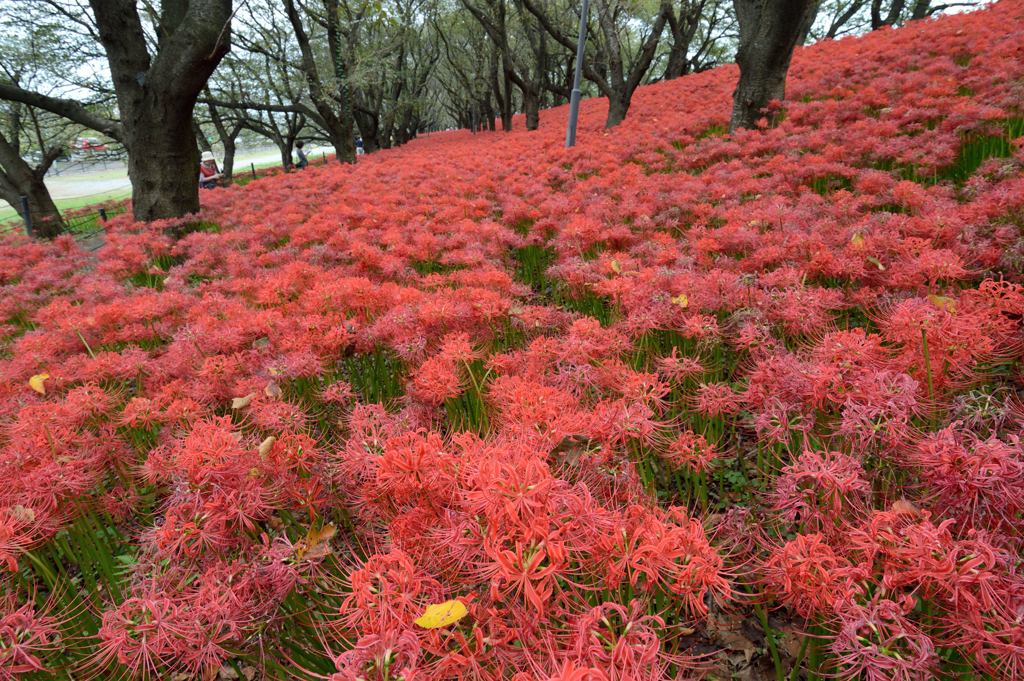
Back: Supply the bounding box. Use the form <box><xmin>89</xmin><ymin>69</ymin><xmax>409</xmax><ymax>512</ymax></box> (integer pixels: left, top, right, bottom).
<box><xmin>0</xmin><ymin>0</ymin><xmax>1024</xmax><ymax>681</ymax></box>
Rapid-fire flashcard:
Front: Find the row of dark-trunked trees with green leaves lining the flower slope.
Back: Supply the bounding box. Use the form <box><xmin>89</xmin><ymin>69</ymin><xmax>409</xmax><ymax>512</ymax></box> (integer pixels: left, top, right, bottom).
<box><xmin>0</xmin><ymin>0</ymin><xmax>974</xmax><ymax>229</ymax></box>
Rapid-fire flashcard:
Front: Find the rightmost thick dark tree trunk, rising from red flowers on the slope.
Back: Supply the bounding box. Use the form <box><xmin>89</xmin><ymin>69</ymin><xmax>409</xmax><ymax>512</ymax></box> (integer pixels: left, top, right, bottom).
<box><xmin>729</xmin><ymin>0</ymin><xmax>814</xmax><ymax>132</ymax></box>
